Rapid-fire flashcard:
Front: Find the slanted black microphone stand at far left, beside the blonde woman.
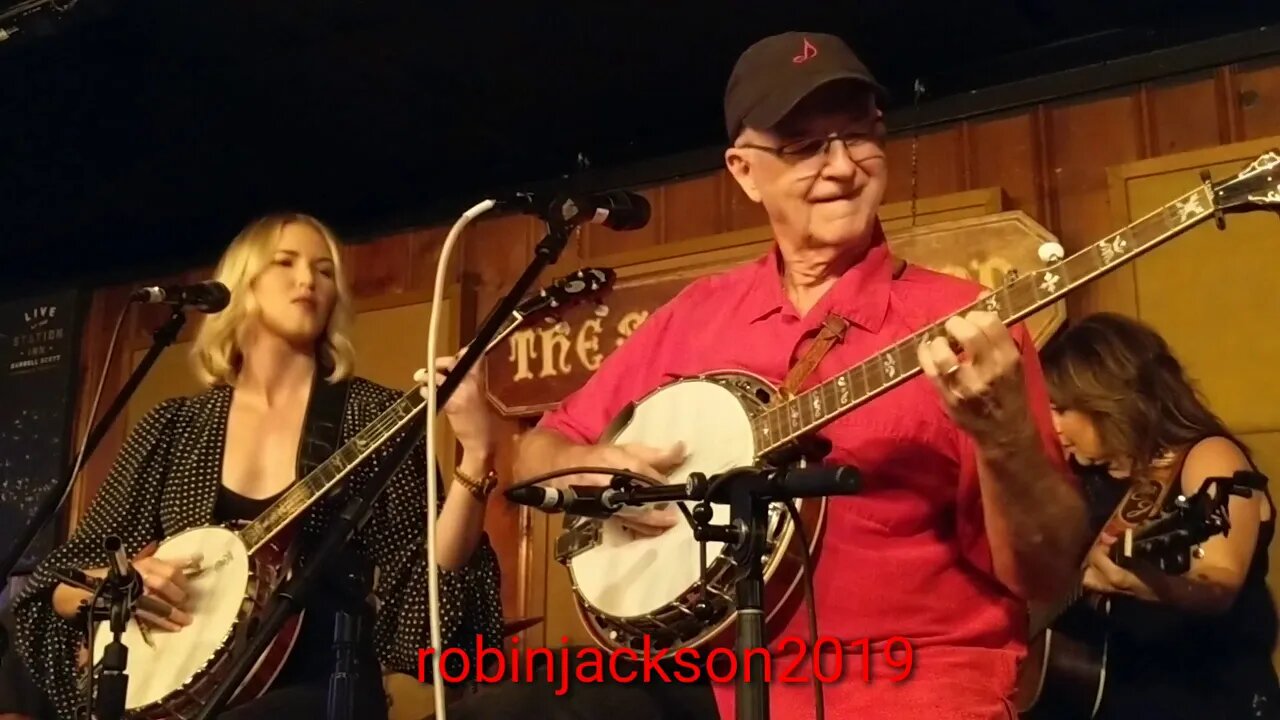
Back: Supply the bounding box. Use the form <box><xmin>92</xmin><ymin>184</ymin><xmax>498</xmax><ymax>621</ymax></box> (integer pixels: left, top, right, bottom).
<box><xmin>0</xmin><ymin>307</ymin><xmax>187</xmax><ymax>653</ymax></box>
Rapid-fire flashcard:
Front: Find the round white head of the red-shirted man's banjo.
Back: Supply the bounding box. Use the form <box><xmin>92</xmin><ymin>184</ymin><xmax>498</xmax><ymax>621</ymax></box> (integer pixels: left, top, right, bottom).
<box><xmin>566</xmin><ymin>374</ymin><xmax>773</xmax><ymax>620</ymax></box>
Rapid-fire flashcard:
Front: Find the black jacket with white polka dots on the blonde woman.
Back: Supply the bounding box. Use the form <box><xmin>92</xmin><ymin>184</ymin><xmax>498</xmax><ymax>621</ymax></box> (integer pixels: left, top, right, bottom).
<box><xmin>14</xmin><ymin>378</ymin><xmax>502</xmax><ymax>719</ymax></box>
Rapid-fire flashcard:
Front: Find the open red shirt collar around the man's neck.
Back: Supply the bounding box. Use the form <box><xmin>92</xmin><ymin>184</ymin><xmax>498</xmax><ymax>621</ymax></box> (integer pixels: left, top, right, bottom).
<box><xmin>746</xmin><ymin>219</ymin><xmax>893</xmax><ymax>332</ymax></box>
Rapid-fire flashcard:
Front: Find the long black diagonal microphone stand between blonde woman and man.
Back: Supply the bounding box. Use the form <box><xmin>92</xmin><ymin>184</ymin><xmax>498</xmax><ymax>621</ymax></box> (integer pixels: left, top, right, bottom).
<box><xmin>195</xmin><ymin>214</ymin><xmax>576</xmax><ymax>720</ymax></box>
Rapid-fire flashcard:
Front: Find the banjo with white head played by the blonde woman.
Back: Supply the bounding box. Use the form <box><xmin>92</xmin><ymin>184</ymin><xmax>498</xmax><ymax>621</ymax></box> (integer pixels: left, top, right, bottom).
<box><xmin>81</xmin><ymin>268</ymin><xmax>616</xmax><ymax>719</ymax></box>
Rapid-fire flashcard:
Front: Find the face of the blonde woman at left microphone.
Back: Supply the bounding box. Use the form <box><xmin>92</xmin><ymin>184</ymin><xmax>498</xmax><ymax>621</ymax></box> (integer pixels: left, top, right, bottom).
<box><xmin>252</xmin><ymin>223</ymin><xmax>338</xmax><ymax>345</ymax></box>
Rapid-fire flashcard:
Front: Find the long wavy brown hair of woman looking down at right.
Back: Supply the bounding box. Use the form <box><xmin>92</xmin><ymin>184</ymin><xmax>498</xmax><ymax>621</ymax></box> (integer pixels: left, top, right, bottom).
<box><xmin>1041</xmin><ymin>313</ymin><xmax>1248</xmax><ymax>468</ymax></box>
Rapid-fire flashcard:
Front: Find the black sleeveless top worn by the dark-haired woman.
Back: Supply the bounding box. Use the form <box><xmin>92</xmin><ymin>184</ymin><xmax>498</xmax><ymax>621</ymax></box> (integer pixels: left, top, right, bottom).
<box><xmin>1082</xmin><ymin>445</ymin><xmax>1280</xmax><ymax>720</ymax></box>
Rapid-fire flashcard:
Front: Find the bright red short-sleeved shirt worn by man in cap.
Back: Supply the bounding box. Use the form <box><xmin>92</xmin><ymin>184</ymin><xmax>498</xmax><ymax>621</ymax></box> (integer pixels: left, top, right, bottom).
<box><xmin>540</xmin><ymin>228</ymin><xmax>1062</xmax><ymax>720</ymax></box>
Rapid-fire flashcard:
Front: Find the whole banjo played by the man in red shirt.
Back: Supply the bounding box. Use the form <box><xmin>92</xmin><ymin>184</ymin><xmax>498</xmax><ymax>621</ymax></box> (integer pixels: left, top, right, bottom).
<box><xmin>556</xmin><ymin>150</ymin><xmax>1280</xmax><ymax>650</ymax></box>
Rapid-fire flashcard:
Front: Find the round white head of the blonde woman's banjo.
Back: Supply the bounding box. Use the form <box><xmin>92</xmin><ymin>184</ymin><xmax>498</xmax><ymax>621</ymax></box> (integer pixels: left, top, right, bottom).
<box><xmin>93</xmin><ymin>527</ymin><xmax>252</xmax><ymax>711</ymax></box>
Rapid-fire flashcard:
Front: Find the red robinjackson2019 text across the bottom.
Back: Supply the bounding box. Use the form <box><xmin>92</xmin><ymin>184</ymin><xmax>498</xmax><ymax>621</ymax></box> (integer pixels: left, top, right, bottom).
<box><xmin>417</xmin><ymin>637</ymin><xmax>914</xmax><ymax>694</ymax></box>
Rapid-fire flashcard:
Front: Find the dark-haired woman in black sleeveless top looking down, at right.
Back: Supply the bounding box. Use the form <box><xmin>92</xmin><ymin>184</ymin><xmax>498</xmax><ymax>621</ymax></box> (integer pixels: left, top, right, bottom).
<box><xmin>1043</xmin><ymin>314</ymin><xmax>1280</xmax><ymax>720</ymax></box>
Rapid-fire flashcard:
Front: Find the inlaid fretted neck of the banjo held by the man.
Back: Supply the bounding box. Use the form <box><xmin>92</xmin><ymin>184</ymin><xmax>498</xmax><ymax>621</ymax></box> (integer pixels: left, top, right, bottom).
<box><xmin>751</xmin><ymin>179</ymin><xmax>1228</xmax><ymax>459</ymax></box>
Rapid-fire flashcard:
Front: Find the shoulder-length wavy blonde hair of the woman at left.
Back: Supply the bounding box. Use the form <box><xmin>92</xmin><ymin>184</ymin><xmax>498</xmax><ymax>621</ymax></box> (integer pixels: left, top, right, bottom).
<box><xmin>192</xmin><ymin>213</ymin><xmax>356</xmax><ymax>387</ymax></box>
